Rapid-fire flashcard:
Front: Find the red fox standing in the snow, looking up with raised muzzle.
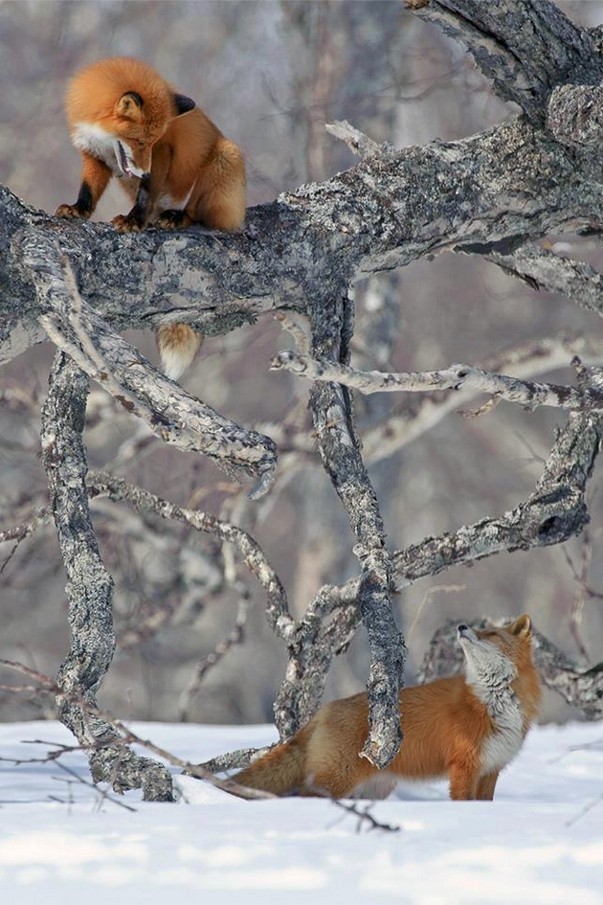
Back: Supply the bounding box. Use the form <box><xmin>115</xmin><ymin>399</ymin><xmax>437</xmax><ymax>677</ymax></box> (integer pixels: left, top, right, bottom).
<box><xmin>233</xmin><ymin>615</ymin><xmax>541</xmax><ymax>800</ymax></box>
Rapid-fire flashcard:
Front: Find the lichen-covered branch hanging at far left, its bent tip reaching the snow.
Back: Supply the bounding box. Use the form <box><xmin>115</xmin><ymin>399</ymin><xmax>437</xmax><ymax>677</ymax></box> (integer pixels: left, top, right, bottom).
<box><xmin>41</xmin><ymin>352</ymin><xmax>173</xmax><ymax>801</ymax></box>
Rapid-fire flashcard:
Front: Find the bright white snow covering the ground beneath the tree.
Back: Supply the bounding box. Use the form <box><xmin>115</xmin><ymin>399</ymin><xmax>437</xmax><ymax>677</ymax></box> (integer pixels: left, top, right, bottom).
<box><xmin>0</xmin><ymin>722</ymin><xmax>603</xmax><ymax>905</ymax></box>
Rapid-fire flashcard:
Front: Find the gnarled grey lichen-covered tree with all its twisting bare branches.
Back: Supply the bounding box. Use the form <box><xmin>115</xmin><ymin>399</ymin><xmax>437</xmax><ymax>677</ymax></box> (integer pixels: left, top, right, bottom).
<box><xmin>0</xmin><ymin>0</ymin><xmax>603</xmax><ymax>799</ymax></box>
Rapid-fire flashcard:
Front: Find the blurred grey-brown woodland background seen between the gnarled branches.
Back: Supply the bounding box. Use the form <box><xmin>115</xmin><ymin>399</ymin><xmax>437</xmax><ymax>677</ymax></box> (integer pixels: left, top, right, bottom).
<box><xmin>0</xmin><ymin>0</ymin><xmax>603</xmax><ymax>722</ymax></box>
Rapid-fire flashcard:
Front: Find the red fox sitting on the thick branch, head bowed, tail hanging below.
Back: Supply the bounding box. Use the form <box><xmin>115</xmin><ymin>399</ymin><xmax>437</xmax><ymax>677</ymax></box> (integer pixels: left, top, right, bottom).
<box><xmin>56</xmin><ymin>57</ymin><xmax>245</xmax><ymax>380</ymax></box>
